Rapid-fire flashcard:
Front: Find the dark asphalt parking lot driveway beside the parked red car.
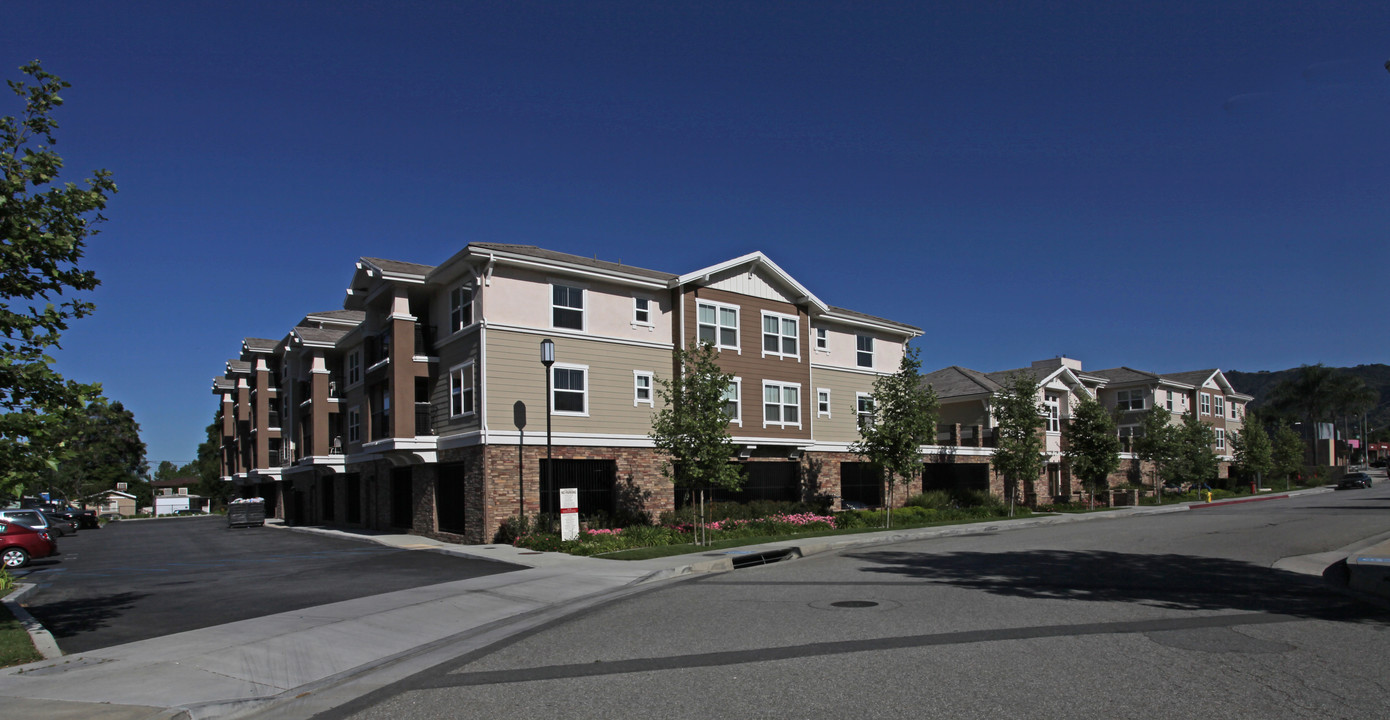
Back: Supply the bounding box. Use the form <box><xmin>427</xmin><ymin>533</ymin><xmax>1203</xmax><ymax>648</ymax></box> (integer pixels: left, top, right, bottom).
<box><xmin>17</xmin><ymin>517</ymin><xmax>518</xmax><ymax>653</ymax></box>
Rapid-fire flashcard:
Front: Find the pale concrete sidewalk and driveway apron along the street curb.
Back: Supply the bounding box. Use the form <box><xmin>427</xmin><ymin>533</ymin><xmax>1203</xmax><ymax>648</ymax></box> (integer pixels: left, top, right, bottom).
<box><xmin>0</xmin><ymin>488</ymin><xmax>1390</xmax><ymax>720</ymax></box>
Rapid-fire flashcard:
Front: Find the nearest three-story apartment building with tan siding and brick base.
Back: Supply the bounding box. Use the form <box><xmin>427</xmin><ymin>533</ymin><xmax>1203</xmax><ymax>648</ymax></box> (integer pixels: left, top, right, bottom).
<box><xmin>214</xmin><ymin>243</ymin><xmax>920</xmax><ymax>542</ymax></box>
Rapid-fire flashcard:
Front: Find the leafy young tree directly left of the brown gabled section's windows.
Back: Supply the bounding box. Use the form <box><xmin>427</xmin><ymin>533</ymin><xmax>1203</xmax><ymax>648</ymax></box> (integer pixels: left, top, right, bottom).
<box><xmin>649</xmin><ymin>342</ymin><xmax>744</xmax><ymax>542</ymax></box>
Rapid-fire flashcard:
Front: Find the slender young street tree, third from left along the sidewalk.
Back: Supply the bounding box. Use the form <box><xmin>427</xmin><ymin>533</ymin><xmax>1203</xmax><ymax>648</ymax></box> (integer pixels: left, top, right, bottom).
<box><xmin>991</xmin><ymin>373</ymin><xmax>1045</xmax><ymax>516</ymax></box>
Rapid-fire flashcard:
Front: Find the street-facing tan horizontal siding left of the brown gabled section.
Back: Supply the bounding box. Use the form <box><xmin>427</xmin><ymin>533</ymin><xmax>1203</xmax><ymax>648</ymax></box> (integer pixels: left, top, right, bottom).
<box><xmin>487</xmin><ymin>329</ymin><xmax>671</xmax><ymax>435</ymax></box>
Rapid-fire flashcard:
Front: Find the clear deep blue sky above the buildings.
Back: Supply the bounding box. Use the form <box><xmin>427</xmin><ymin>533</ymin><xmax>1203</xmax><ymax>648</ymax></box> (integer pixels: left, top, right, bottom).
<box><xmin>0</xmin><ymin>0</ymin><xmax>1390</xmax><ymax>466</ymax></box>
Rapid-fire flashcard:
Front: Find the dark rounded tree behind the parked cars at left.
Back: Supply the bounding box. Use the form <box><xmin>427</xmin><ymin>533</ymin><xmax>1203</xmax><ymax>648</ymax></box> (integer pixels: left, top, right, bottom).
<box><xmin>51</xmin><ymin>398</ymin><xmax>149</xmax><ymax>502</ymax></box>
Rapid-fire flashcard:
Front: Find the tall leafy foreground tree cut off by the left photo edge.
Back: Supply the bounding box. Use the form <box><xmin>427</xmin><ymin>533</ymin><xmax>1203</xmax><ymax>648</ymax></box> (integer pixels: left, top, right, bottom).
<box><xmin>0</xmin><ymin>60</ymin><xmax>115</xmax><ymax>492</ymax></box>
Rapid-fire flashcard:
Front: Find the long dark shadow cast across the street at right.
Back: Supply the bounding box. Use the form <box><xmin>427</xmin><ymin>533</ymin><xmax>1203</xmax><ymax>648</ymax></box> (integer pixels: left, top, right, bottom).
<box><xmin>849</xmin><ymin>550</ymin><xmax>1387</xmax><ymax>621</ymax></box>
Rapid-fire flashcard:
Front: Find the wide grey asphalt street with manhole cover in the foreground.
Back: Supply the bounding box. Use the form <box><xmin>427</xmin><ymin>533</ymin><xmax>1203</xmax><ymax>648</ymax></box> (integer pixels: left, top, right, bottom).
<box><xmin>321</xmin><ymin>484</ymin><xmax>1390</xmax><ymax>720</ymax></box>
